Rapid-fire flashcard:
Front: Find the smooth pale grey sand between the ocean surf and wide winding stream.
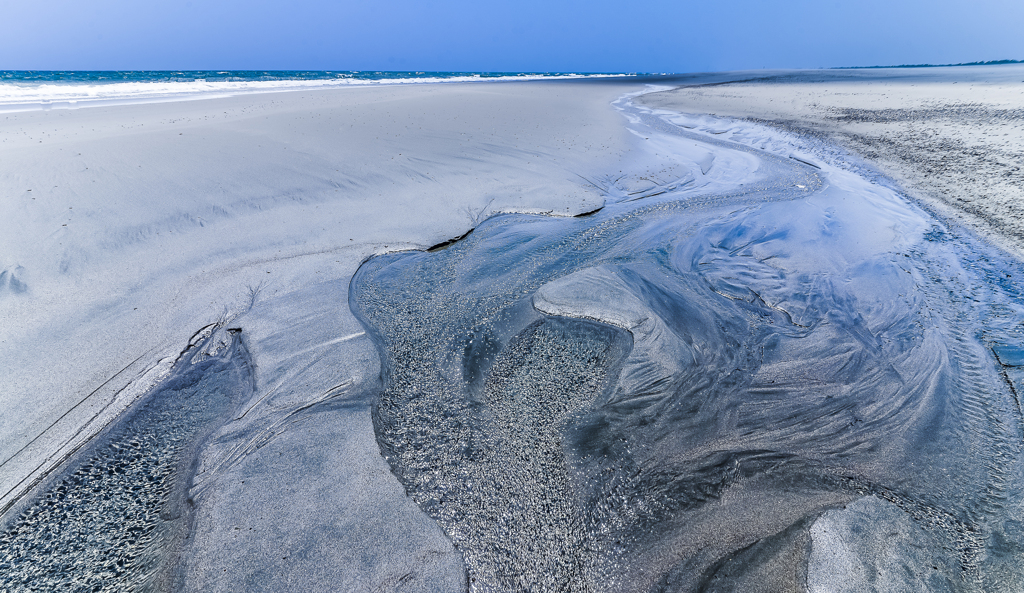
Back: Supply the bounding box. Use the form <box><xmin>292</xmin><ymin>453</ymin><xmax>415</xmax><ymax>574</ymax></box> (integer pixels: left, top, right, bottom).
<box><xmin>0</xmin><ymin>77</ymin><xmax>637</xmax><ymax>591</ymax></box>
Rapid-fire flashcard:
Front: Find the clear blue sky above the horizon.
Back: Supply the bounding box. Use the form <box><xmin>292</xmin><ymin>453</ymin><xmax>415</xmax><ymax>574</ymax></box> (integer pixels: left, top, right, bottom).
<box><xmin>0</xmin><ymin>0</ymin><xmax>1024</xmax><ymax>72</ymax></box>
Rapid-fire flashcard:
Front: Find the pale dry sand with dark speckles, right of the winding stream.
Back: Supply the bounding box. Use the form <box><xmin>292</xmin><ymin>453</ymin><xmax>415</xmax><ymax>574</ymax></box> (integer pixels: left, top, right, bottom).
<box><xmin>640</xmin><ymin>65</ymin><xmax>1024</xmax><ymax>256</ymax></box>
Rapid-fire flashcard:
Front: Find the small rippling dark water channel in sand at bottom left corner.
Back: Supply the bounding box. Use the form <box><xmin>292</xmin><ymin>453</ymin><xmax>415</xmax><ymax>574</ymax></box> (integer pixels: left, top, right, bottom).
<box><xmin>0</xmin><ymin>327</ymin><xmax>253</xmax><ymax>592</ymax></box>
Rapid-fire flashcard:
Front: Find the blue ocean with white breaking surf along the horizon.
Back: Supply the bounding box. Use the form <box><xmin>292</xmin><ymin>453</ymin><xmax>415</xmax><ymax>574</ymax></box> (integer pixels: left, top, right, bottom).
<box><xmin>0</xmin><ymin>70</ymin><xmax>629</xmax><ymax>112</ymax></box>
